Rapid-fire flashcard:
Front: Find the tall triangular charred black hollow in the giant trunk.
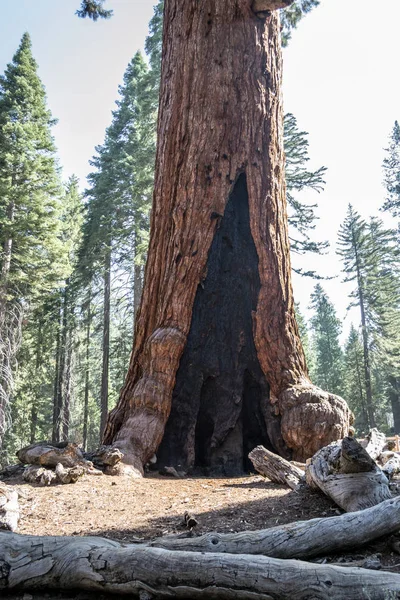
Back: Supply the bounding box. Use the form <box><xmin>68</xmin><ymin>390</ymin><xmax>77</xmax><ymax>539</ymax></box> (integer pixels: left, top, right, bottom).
<box><xmin>158</xmin><ymin>173</ymin><xmax>282</xmax><ymax>475</ymax></box>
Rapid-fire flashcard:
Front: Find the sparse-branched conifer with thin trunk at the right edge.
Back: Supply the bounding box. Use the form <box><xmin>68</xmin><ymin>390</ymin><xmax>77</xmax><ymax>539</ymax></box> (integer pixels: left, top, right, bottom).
<box><xmin>338</xmin><ymin>206</ymin><xmax>400</xmax><ymax>427</ymax></box>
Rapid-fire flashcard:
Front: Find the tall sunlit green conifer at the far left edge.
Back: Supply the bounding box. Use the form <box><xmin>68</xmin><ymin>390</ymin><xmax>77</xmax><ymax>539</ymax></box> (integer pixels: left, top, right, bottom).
<box><xmin>0</xmin><ymin>33</ymin><xmax>62</xmax><ymax>448</ymax></box>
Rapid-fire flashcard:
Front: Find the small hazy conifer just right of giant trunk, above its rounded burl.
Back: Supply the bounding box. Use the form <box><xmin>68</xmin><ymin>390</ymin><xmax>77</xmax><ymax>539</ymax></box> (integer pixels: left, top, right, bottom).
<box><xmin>311</xmin><ymin>284</ymin><xmax>344</xmax><ymax>395</ymax></box>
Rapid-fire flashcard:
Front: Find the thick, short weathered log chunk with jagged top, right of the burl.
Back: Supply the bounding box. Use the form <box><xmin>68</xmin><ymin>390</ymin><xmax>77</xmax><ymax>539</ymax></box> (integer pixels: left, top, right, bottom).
<box><xmin>306</xmin><ymin>437</ymin><xmax>391</xmax><ymax>512</ymax></box>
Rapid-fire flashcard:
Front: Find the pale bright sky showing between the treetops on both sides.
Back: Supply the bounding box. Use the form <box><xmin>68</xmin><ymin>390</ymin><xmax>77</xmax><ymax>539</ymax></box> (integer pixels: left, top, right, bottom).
<box><xmin>0</xmin><ymin>0</ymin><xmax>400</xmax><ymax>340</ymax></box>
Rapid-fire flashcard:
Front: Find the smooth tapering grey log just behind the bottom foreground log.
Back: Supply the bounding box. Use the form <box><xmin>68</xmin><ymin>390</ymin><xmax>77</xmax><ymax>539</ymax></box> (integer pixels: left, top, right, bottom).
<box><xmin>151</xmin><ymin>497</ymin><xmax>400</xmax><ymax>558</ymax></box>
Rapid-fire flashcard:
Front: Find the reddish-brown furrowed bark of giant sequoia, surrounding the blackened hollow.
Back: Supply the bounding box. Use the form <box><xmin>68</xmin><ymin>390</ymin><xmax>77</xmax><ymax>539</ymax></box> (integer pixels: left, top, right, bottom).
<box><xmin>104</xmin><ymin>0</ymin><xmax>350</xmax><ymax>473</ymax></box>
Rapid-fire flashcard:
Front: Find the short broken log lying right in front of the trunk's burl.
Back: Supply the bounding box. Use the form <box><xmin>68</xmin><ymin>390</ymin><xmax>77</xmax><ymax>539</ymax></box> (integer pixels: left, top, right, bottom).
<box><xmin>249</xmin><ymin>446</ymin><xmax>304</xmax><ymax>490</ymax></box>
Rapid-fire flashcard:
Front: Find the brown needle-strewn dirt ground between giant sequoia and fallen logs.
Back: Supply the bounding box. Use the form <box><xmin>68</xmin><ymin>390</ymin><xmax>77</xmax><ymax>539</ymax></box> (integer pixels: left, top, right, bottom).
<box><xmin>6</xmin><ymin>474</ymin><xmax>400</xmax><ymax>600</ymax></box>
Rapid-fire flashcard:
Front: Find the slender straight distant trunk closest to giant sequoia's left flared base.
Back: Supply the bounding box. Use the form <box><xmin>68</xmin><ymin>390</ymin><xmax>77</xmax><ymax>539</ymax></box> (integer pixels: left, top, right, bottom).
<box><xmin>100</xmin><ymin>244</ymin><xmax>111</xmax><ymax>440</ymax></box>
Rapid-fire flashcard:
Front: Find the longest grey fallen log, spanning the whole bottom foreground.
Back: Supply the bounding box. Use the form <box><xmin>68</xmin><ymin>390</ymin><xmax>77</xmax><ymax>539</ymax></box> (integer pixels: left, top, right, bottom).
<box><xmin>0</xmin><ymin>532</ymin><xmax>400</xmax><ymax>600</ymax></box>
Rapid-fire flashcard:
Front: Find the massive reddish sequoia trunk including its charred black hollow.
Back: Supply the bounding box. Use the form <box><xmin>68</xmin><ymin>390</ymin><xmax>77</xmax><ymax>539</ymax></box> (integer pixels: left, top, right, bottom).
<box><xmin>104</xmin><ymin>0</ymin><xmax>350</xmax><ymax>474</ymax></box>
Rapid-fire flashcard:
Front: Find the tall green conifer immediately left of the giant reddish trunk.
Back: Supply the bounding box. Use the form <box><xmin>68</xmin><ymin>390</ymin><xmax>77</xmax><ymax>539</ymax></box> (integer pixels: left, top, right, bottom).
<box><xmin>81</xmin><ymin>53</ymin><xmax>158</xmax><ymax>438</ymax></box>
